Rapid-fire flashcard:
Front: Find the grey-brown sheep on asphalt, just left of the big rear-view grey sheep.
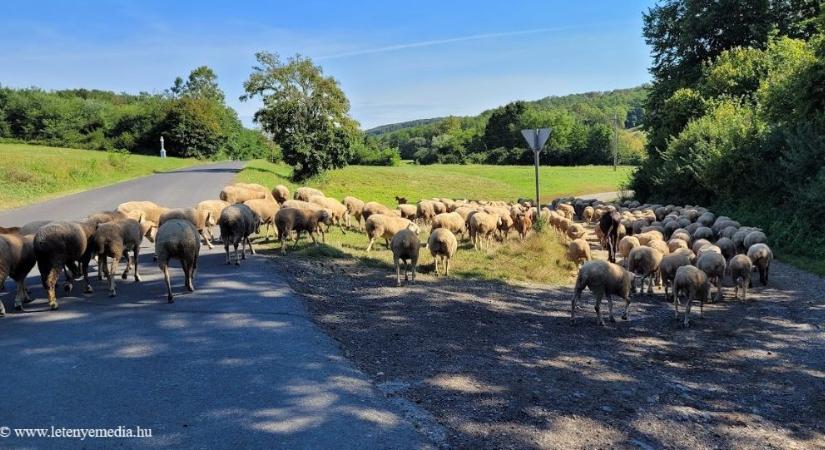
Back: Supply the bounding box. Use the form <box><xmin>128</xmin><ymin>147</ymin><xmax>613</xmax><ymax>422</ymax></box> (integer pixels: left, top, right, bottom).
<box><xmin>94</xmin><ymin>219</ymin><xmax>150</xmax><ymax>297</ymax></box>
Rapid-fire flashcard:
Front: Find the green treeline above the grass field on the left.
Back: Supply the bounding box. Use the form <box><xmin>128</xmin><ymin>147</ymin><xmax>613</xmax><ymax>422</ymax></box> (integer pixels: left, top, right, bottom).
<box><xmin>0</xmin><ymin>67</ymin><xmax>278</xmax><ymax>159</ymax></box>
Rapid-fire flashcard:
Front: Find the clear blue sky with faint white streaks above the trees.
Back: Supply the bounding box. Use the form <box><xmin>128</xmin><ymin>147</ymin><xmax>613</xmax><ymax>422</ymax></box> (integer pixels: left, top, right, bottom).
<box><xmin>0</xmin><ymin>0</ymin><xmax>654</xmax><ymax>129</ymax></box>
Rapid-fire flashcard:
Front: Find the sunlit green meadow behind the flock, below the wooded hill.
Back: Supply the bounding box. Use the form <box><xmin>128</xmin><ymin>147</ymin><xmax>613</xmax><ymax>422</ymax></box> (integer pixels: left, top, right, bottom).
<box><xmin>238</xmin><ymin>161</ymin><xmax>633</xmax><ymax>207</ymax></box>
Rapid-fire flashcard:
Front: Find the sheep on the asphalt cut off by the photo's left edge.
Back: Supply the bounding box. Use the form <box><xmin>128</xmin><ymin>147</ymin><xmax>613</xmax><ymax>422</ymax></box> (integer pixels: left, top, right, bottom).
<box><xmin>0</xmin><ymin>229</ymin><xmax>37</xmax><ymax>317</ymax></box>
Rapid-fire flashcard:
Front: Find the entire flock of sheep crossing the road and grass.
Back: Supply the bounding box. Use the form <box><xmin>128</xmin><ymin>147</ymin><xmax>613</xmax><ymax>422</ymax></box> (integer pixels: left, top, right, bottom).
<box><xmin>0</xmin><ymin>183</ymin><xmax>773</xmax><ymax>326</ymax></box>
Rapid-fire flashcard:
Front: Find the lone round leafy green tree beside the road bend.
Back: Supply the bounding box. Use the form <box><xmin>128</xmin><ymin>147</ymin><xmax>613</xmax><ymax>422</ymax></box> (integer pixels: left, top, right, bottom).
<box><xmin>241</xmin><ymin>52</ymin><xmax>361</xmax><ymax>180</ymax></box>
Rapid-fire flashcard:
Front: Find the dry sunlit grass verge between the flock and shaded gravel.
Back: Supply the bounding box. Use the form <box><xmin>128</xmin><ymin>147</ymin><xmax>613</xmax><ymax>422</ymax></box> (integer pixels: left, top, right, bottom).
<box><xmin>256</xmin><ymin>226</ymin><xmax>575</xmax><ymax>285</ymax></box>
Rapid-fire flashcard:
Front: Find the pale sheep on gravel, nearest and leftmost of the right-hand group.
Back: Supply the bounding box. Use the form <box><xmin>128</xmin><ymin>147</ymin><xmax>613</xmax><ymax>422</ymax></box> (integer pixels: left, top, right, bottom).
<box><xmin>570</xmin><ymin>260</ymin><xmax>633</xmax><ymax>326</ymax></box>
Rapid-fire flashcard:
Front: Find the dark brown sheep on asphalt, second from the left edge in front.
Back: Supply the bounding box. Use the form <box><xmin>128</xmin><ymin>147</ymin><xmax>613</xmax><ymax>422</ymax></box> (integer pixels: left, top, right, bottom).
<box><xmin>33</xmin><ymin>222</ymin><xmax>94</xmax><ymax>310</ymax></box>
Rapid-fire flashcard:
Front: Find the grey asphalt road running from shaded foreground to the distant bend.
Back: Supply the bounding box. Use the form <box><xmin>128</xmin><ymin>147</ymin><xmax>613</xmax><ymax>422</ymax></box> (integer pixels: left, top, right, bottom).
<box><xmin>0</xmin><ymin>163</ymin><xmax>426</xmax><ymax>449</ymax></box>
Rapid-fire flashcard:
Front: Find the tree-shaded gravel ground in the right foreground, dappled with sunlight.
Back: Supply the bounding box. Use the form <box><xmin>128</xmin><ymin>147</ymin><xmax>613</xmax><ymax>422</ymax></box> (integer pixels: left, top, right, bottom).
<box><xmin>262</xmin><ymin>243</ymin><xmax>825</xmax><ymax>449</ymax></box>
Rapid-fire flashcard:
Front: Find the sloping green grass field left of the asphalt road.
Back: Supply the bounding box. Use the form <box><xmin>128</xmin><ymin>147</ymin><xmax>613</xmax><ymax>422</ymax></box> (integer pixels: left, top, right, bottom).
<box><xmin>0</xmin><ymin>143</ymin><xmax>198</xmax><ymax>210</ymax></box>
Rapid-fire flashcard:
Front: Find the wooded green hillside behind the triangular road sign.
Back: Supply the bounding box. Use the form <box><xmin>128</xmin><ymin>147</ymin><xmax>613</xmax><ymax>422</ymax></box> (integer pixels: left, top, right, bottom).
<box><xmin>367</xmin><ymin>87</ymin><xmax>647</xmax><ymax>165</ymax></box>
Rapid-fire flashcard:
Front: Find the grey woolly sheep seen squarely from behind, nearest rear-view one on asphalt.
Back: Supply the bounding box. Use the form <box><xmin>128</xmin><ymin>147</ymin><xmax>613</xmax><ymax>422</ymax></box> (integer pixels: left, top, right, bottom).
<box><xmin>155</xmin><ymin>219</ymin><xmax>200</xmax><ymax>303</ymax></box>
